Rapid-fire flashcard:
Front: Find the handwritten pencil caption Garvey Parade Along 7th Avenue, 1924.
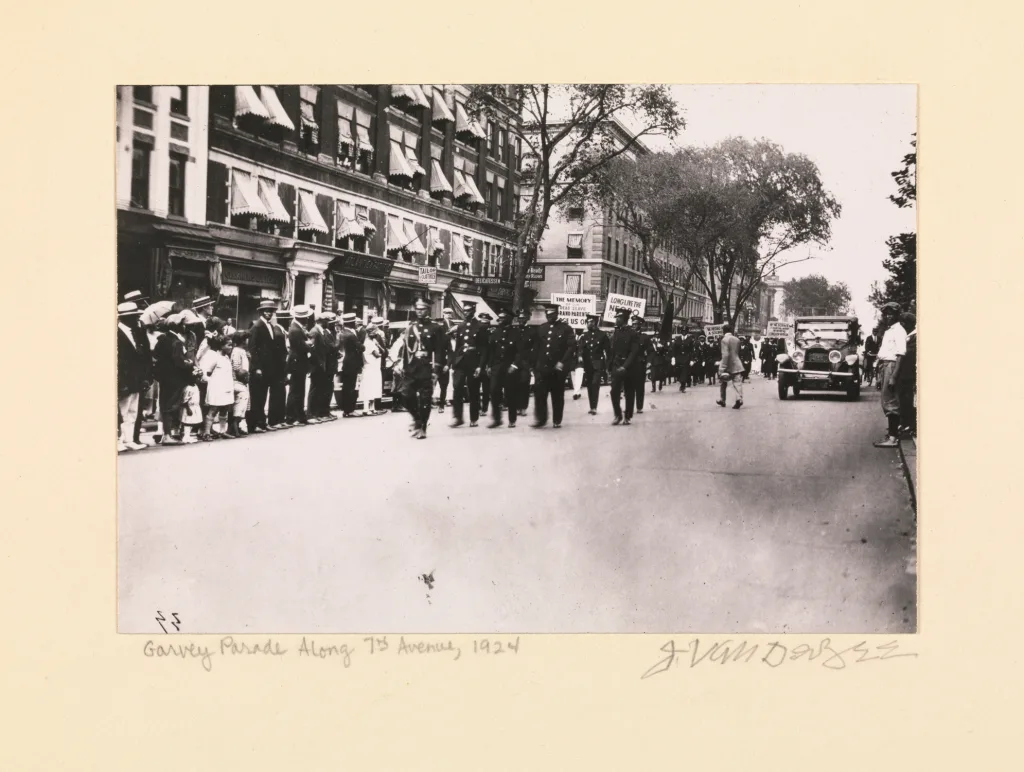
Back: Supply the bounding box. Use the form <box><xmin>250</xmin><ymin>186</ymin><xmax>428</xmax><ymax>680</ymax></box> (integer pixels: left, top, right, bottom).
<box><xmin>142</xmin><ymin>635</ymin><xmax>519</xmax><ymax>672</ymax></box>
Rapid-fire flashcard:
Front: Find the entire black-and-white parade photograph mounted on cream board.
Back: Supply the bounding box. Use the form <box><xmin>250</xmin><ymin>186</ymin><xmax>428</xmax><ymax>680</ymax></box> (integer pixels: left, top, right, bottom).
<box><xmin>117</xmin><ymin>83</ymin><xmax>919</xmax><ymax>635</ymax></box>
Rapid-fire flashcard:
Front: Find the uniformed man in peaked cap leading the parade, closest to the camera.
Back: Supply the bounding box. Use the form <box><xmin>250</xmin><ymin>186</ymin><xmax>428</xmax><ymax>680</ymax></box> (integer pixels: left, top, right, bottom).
<box><xmin>395</xmin><ymin>298</ymin><xmax>446</xmax><ymax>439</ymax></box>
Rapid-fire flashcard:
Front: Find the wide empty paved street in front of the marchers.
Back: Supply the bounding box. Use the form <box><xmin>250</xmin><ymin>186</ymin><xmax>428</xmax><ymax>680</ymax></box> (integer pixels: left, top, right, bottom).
<box><xmin>118</xmin><ymin>376</ymin><xmax>916</xmax><ymax>633</ymax></box>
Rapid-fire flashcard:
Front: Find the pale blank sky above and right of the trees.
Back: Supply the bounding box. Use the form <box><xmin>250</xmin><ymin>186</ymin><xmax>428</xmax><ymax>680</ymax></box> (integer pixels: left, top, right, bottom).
<box><xmin>634</xmin><ymin>85</ymin><xmax>916</xmax><ymax>325</ymax></box>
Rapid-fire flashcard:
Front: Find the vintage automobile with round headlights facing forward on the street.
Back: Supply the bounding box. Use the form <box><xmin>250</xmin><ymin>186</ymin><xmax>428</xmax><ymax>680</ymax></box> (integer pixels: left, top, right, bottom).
<box><xmin>775</xmin><ymin>316</ymin><xmax>861</xmax><ymax>400</ymax></box>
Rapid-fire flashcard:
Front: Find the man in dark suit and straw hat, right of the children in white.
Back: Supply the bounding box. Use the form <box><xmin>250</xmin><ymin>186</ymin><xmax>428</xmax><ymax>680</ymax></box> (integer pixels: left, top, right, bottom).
<box><xmin>247</xmin><ymin>300</ymin><xmax>288</xmax><ymax>434</ymax></box>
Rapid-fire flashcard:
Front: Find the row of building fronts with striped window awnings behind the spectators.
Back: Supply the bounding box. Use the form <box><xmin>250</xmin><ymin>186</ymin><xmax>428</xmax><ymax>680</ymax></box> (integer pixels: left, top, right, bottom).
<box><xmin>118</xmin><ymin>85</ymin><xmax>519</xmax><ymax>327</ymax></box>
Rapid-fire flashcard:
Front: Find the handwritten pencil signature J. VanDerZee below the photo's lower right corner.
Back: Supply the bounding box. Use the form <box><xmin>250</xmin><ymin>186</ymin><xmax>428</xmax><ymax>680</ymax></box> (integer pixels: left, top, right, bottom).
<box><xmin>640</xmin><ymin>638</ymin><xmax>918</xmax><ymax>680</ymax></box>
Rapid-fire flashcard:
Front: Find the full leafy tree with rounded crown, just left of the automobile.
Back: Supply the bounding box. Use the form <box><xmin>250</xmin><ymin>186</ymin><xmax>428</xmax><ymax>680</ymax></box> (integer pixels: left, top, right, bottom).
<box><xmin>673</xmin><ymin>137</ymin><xmax>842</xmax><ymax>324</ymax></box>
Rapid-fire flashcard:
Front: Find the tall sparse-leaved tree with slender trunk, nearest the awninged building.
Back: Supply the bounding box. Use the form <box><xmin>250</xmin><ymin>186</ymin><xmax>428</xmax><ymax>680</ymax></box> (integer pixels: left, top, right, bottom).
<box><xmin>467</xmin><ymin>83</ymin><xmax>685</xmax><ymax>309</ymax></box>
